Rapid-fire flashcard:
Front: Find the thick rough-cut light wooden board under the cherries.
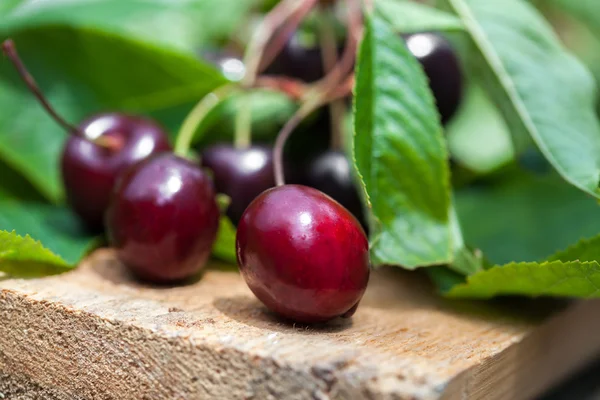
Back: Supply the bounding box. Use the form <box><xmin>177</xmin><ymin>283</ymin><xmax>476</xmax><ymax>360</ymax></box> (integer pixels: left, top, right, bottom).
<box><xmin>0</xmin><ymin>250</ymin><xmax>600</xmax><ymax>400</ymax></box>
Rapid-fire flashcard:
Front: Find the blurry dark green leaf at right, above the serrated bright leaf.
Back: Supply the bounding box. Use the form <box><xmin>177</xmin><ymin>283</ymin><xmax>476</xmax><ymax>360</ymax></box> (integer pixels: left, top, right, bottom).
<box><xmin>455</xmin><ymin>173</ymin><xmax>600</xmax><ymax>264</ymax></box>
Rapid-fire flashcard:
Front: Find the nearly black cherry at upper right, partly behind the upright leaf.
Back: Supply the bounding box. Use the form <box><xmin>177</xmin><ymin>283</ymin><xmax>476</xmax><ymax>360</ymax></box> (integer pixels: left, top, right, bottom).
<box><xmin>404</xmin><ymin>32</ymin><xmax>463</xmax><ymax>124</ymax></box>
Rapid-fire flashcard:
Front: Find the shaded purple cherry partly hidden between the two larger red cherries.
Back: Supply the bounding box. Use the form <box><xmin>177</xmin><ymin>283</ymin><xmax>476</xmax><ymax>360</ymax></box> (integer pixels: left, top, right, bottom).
<box><xmin>201</xmin><ymin>144</ymin><xmax>275</xmax><ymax>225</ymax></box>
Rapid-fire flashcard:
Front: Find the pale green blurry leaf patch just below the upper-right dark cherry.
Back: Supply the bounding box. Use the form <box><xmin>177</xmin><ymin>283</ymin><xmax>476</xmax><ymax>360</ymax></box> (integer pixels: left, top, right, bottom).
<box><xmin>446</xmin><ymin>84</ymin><xmax>514</xmax><ymax>174</ymax></box>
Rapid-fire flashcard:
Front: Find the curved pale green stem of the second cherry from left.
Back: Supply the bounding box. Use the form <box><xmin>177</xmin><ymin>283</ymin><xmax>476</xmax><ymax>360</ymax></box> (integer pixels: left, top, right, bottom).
<box><xmin>174</xmin><ymin>84</ymin><xmax>238</xmax><ymax>157</ymax></box>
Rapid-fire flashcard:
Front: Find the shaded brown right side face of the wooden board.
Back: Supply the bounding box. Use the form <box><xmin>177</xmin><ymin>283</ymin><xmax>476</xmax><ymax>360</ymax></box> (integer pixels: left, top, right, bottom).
<box><xmin>442</xmin><ymin>300</ymin><xmax>600</xmax><ymax>400</ymax></box>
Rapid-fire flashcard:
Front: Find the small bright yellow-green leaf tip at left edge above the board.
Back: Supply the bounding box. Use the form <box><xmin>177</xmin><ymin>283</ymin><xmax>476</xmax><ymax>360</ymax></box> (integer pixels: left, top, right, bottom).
<box><xmin>0</xmin><ymin>230</ymin><xmax>71</xmax><ymax>278</ymax></box>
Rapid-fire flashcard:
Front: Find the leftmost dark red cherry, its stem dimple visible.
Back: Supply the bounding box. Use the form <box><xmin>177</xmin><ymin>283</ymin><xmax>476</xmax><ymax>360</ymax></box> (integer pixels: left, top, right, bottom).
<box><xmin>61</xmin><ymin>113</ymin><xmax>171</xmax><ymax>231</ymax></box>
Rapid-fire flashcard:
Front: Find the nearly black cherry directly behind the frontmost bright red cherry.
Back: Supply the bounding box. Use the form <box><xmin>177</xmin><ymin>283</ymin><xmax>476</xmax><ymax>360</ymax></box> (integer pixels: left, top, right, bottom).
<box><xmin>299</xmin><ymin>150</ymin><xmax>367</xmax><ymax>230</ymax></box>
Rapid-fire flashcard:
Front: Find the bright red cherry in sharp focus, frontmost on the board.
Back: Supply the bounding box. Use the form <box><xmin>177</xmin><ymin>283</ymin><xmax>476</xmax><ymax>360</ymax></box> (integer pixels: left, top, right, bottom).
<box><xmin>236</xmin><ymin>185</ymin><xmax>369</xmax><ymax>323</ymax></box>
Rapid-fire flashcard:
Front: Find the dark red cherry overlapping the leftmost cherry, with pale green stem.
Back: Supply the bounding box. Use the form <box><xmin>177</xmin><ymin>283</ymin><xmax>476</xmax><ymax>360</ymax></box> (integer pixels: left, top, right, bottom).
<box><xmin>106</xmin><ymin>153</ymin><xmax>219</xmax><ymax>283</ymax></box>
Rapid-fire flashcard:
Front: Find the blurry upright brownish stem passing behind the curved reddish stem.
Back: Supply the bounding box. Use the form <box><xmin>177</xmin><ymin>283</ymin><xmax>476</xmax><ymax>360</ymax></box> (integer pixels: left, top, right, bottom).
<box><xmin>319</xmin><ymin>6</ymin><xmax>345</xmax><ymax>150</ymax></box>
